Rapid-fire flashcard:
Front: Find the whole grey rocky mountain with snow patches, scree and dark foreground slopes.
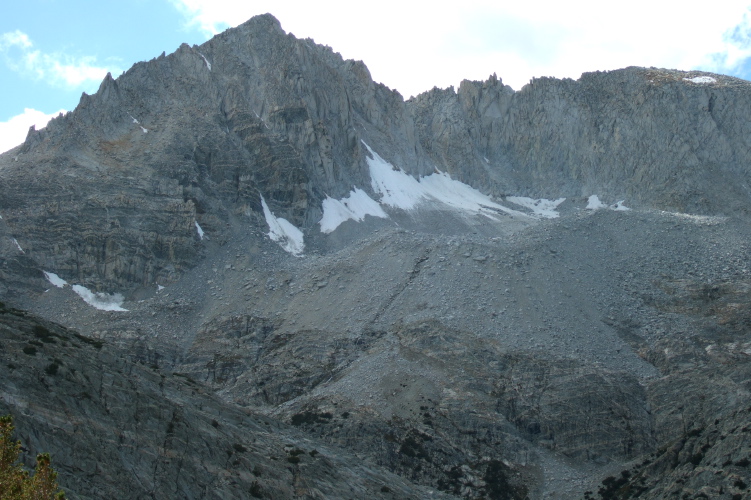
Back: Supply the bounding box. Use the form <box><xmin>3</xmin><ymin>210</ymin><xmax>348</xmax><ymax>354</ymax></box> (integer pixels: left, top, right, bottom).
<box><xmin>0</xmin><ymin>15</ymin><xmax>751</xmax><ymax>500</ymax></box>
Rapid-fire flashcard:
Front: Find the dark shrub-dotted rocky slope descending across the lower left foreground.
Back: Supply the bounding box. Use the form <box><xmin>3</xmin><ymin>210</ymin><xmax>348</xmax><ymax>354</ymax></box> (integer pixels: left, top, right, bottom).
<box><xmin>0</xmin><ymin>306</ymin><xmax>452</xmax><ymax>498</ymax></box>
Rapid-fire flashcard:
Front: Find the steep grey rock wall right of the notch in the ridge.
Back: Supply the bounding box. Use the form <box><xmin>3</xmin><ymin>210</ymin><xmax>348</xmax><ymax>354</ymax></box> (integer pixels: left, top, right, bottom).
<box><xmin>407</xmin><ymin>67</ymin><xmax>751</xmax><ymax>213</ymax></box>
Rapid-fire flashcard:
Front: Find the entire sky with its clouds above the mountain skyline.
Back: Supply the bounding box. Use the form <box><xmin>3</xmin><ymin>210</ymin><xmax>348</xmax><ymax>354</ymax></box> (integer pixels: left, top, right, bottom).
<box><xmin>0</xmin><ymin>0</ymin><xmax>751</xmax><ymax>151</ymax></box>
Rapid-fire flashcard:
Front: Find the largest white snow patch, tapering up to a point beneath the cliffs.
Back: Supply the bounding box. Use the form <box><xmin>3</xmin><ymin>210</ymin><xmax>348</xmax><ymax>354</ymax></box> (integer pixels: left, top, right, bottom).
<box><xmin>363</xmin><ymin>141</ymin><xmax>526</xmax><ymax>219</ymax></box>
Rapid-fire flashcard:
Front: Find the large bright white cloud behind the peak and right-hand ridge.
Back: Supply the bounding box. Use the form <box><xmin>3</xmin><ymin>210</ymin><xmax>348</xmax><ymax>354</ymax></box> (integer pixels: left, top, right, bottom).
<box><xmin>172</xmin><ymin>0</ymin><xmax>751</xmax><ymax>97</ymax></box>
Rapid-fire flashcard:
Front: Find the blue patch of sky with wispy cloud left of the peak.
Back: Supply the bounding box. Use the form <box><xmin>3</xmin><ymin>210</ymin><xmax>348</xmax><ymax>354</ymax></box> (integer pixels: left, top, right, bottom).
<box><xmin>0</xmin><ymin>0</ymin><xmax>206</xmax><ymax>121</ymax></box>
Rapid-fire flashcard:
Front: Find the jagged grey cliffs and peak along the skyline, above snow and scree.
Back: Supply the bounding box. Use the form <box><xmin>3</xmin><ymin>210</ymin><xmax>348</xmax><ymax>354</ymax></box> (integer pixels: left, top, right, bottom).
<box><xmin>0</xmin><ymin>15</ymin><xmax>751</xmax><ymax>289</ymax></box>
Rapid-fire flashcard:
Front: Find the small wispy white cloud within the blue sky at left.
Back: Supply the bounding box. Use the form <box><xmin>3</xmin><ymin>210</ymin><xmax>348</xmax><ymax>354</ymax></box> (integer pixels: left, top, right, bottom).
<box><xmin>0</xmin><ymin>30</ymin><xmax>120</xmax><ymax>89</ymax></box>
